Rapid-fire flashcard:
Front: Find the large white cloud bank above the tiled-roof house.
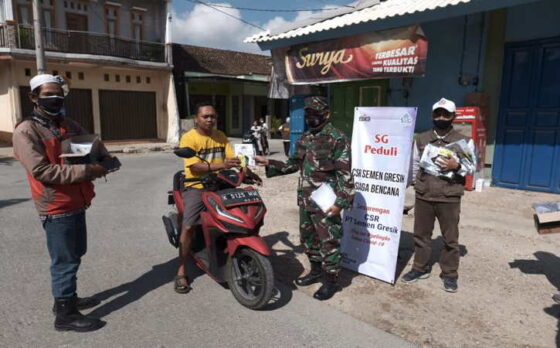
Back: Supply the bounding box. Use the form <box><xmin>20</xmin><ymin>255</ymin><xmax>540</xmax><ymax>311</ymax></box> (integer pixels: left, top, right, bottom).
<box><xmin>172</xmin><ymin>3</ymin><xmax>332</xmax><ymax>55</ymax></box>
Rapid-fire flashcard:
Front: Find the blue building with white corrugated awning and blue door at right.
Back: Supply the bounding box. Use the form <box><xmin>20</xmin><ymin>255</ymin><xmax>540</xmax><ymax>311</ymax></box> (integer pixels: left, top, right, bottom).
<box><xmin>250</xmin><ymin>0</ymin><xmax>560</xmax><ymax>193</ymax></box>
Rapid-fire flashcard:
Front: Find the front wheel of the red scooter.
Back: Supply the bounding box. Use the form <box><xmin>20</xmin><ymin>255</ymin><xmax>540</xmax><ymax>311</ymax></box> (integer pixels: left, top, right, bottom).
<box><xmin>226</xmin><ymin>248</ymin><xmax>274</xmax><ymax>309</ymax></box>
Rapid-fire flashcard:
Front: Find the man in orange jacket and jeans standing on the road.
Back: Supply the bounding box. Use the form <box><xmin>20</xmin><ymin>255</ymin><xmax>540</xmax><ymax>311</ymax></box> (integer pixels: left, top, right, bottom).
<box><xmin>13</xmin><ymin>74</ymin><xmax>114</xmax><ymax>332</ymax></box>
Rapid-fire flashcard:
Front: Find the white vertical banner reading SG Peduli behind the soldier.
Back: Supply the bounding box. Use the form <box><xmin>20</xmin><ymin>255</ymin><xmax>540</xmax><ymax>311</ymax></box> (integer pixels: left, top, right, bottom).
<box><xmin>342</xmin><ymin>107</ymin><xmax>417</xmax><ymax>283</ymax></box>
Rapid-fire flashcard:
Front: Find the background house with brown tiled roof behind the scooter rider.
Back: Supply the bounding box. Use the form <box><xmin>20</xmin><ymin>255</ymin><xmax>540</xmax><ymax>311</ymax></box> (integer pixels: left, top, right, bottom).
<box><xmin>173</xmin><ymin>44</ymin><xmax>280</xmax><ymax>137</ymax></box>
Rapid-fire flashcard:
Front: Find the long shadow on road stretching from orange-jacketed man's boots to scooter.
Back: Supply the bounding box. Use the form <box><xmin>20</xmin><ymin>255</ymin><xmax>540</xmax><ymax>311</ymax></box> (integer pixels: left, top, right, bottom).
<box><xmin>89</xmin><ymin>258</ymin><xmax>177</xmax><ymax>318</ymax></box>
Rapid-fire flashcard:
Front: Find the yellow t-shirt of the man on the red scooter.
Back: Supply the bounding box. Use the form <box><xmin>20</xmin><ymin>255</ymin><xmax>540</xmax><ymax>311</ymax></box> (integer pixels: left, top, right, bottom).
<box><xmin>179</xmin><ymin>128</ymin><xmax>235</xmax><ymax>188</ymax></box>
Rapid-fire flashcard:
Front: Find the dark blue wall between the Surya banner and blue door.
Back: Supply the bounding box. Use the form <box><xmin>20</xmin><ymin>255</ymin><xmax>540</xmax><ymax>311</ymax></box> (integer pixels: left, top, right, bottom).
<box><xmin>388</xmin><ymin>0</ymin><xmax>560</xmax><ymax>169</ymax></box>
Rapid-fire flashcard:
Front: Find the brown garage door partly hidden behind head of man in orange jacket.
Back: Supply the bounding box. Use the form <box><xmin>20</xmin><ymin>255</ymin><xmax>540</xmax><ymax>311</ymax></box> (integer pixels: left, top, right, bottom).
<box><xmin>19</xmin><ymin>86</ymin><xmax>93</xmax><ymax>133</ymax></box>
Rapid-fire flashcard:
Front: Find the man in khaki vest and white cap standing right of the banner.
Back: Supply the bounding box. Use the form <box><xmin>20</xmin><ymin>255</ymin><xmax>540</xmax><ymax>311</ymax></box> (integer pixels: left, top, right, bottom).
<box><xmin>401</xmin><ymin>98</ymin><xmax>476</xmax><ymax>292</ymax></box>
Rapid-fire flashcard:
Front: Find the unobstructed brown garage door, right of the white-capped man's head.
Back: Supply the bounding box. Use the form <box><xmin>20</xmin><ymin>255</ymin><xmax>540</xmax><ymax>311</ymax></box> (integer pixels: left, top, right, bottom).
<box><xmin>99</xmin><ymin>90</ymin><xmax>157</xmax><ymax>140</ymax></box>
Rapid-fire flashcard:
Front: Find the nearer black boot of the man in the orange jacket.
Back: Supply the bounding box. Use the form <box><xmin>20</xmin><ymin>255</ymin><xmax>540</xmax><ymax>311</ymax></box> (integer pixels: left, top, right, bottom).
<box><xmin>54</xmin><ymin>297</ymin><xmax>105</xmax><ymax>332</ymax></box>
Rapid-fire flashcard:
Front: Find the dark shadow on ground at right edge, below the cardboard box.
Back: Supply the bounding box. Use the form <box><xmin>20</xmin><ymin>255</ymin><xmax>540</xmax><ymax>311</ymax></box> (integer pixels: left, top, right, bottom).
<box><xmin>509</xmin><ymin>251</ymin><xmax>560</xmax><ymax>347</ymax></box>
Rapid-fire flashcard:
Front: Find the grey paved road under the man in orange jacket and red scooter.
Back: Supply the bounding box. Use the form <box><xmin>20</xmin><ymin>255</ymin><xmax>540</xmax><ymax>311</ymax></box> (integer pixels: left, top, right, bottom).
<box><xmin>0</xmin><ymin>153</ymin><xmax>411</xmax><ymax>347</ymax></box>
